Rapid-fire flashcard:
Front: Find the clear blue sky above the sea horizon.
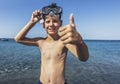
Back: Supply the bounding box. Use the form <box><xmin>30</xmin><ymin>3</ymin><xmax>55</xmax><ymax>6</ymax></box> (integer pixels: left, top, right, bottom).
<box><xmin>0</xmin><ymin>0</ymin><xmax>120</xmax><ymax>40</ymax></box>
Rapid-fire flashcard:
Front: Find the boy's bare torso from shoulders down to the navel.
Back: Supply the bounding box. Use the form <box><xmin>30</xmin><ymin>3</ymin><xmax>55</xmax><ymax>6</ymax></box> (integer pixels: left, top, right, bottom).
<box><xmin>38</xmin><ymin>40</ymin><xmax>67</xmax><ymax>84</ymax></box>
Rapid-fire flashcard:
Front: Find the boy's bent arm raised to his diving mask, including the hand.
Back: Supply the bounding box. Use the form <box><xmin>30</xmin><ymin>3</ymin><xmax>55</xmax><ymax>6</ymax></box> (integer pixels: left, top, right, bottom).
<box><xmin>15</xmin><ymin>10</ymin><xmax>41</xmax><ymax>46</ymax></box>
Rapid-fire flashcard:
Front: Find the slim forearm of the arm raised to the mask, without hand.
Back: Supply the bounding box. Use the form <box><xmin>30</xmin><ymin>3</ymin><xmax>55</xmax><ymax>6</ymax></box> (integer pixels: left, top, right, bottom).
<box><xmin>15</xmin><ymin>21</ymin><xmax>35</xmax><ymax>42</ymax></box>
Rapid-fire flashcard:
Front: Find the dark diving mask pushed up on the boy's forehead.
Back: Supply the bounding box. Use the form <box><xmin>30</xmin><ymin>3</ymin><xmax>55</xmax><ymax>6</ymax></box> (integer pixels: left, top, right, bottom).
<box><xmin>42</xmin><ymin>4</ymin><xmax>62</xmax><ymax>15</ymax></box>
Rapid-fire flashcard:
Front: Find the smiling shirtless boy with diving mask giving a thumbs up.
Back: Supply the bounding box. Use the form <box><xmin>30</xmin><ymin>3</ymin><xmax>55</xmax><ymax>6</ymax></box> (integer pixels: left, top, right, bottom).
<box><xmin>15</xmin><ymin>4</ymin><xmax>89</xmax><ymax>84</ymax></box>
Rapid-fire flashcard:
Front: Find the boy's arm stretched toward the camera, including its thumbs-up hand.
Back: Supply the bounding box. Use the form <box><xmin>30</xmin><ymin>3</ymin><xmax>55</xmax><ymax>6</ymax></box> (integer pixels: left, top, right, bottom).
<box><xmin>60</xmin><ymin>15</ymin><xmax>89</xmax><ymax>61</ymax></box>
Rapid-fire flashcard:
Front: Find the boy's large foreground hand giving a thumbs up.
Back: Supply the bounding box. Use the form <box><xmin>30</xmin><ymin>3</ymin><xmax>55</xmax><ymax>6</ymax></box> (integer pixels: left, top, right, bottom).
<box><xmin>59</xmin><ymin>14</ymin><xmax>82</xmax><ymax>44</ymax></box>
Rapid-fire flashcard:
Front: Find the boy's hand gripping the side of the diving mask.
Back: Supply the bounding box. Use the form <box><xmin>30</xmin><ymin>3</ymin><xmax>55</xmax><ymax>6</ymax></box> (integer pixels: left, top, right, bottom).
<box><xmin>31</xmin><ymin>10</ymin><xmax>42</xmax><ymax>23</ymax></box>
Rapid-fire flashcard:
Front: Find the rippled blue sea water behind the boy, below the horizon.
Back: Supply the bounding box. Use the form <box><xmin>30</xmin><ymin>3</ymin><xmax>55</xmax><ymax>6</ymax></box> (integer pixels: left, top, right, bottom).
<box><xmin>0</xmin><ymin>40</ymin><xmax>120</xmax><ymax>84</ymax></box>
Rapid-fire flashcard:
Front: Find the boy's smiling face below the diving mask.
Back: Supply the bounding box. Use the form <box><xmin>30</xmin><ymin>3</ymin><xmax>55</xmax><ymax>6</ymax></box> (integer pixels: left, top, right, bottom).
<box><xmin>43</xmin><ymin>16</ymin><xmax>61</xmax><ymax>35</ymax></box>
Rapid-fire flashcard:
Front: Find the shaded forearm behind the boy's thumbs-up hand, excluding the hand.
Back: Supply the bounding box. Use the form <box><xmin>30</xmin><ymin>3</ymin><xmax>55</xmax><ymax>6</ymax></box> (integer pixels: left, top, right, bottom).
<box><xmin>65</xmin><ymin>36</ymin><xmax>89</xmax><ymax>61</ymax></box>
